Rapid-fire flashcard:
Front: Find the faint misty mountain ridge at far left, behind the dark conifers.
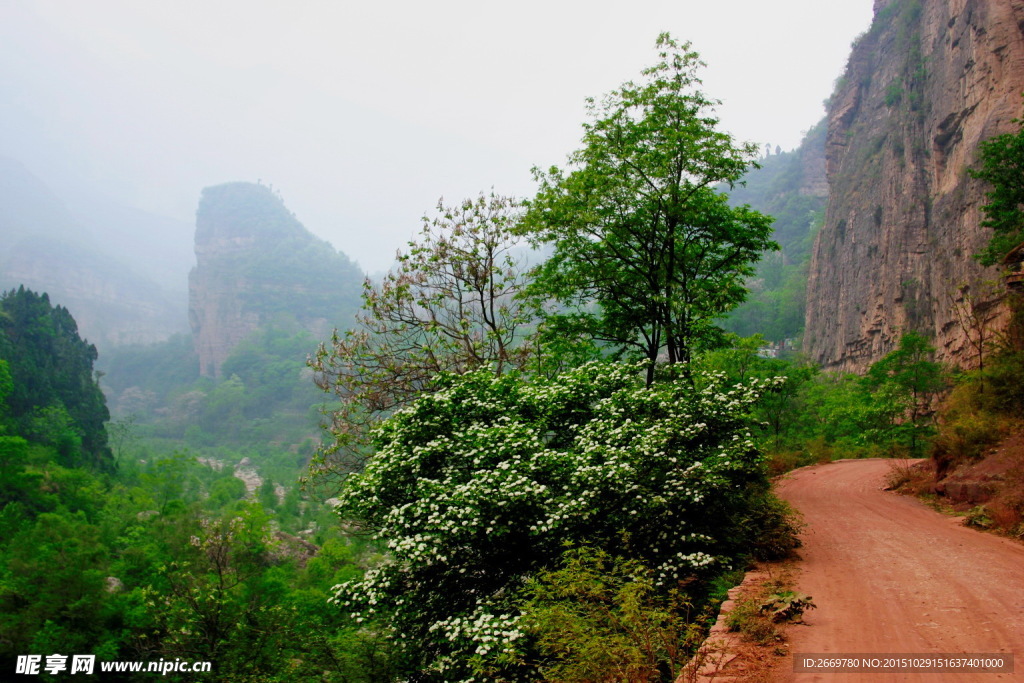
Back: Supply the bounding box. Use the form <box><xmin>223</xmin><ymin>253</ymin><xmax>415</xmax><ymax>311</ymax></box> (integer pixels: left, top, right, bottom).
<box><xmin>0</xmin><ymin>158</ymin><xmax>185</xmax><ymax>349</ymax></box>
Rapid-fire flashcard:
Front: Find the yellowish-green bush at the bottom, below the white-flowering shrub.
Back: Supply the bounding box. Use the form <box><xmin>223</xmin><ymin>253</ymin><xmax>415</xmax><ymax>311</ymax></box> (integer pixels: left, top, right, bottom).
<box><xmin>516</xmin><ymin>547</ymin><xmax>702</xmax><ymax>683</ymax></box>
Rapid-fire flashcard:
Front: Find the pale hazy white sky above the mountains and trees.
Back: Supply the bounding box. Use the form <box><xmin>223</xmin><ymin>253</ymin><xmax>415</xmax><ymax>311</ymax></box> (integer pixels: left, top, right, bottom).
<box><xmin>0</xmin><ymin>0</ymin><xmax>872</xmax><ymax>270</ymax></box>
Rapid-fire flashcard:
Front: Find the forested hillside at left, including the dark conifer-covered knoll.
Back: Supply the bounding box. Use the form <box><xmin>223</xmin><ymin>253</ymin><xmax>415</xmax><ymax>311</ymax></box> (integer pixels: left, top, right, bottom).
<box><xmin>0</xmin><ymin>289</ymin><xmax>387</xmax><ymax>681</ymax></box>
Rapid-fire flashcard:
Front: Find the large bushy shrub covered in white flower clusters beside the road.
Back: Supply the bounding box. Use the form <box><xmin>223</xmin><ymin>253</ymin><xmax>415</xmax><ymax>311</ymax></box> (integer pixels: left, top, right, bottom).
<box><xmin>333</xmin><ymin>362</ymin><xmax>771</xmax><ymax>681</ymax></box>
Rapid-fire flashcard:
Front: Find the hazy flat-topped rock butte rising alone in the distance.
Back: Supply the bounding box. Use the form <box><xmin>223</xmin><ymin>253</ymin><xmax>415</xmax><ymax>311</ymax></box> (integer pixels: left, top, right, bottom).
<box><xmin>188</xmin><ymin>182</ymin><xmax>362</xmax><ymax>377</ymax></box>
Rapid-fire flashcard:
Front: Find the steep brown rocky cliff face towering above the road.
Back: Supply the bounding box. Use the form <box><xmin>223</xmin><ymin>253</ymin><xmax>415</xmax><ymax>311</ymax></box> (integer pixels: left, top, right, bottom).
<box><xmin>805</xmin><ymin>0</ymin><xmax>1024</xmax><ymax>371</ymax></box>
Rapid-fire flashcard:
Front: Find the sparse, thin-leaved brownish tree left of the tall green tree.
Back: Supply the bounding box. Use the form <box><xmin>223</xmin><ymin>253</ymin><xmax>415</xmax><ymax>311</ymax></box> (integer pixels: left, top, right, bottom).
<box><xmin>309</xmin><ymin>193</ymin><xmax>529</xmax><ymax>481</ymax></box>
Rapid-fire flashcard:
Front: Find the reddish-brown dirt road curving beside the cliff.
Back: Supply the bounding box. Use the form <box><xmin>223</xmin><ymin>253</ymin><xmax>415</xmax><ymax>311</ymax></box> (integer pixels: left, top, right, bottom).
<box><xmin>776</xmin><ymin>460</ymin><xmax>1024</xmax><ymax>683</ymax></box>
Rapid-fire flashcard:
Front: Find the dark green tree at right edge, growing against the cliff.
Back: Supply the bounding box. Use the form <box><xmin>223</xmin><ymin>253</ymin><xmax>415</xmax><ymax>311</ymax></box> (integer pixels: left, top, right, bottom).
<box><xmin>970</xmin><ymin>119</ymin><xmax>1024</xmax><ymax>265</ymax></box>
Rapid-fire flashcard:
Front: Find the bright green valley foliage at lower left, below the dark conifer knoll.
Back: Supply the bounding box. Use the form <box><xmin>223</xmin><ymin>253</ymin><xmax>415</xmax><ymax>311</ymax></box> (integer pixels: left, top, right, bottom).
<box><xmin>0</xmin><ymin>436</ymin><xmax>393</xmax><ymax>682</ymax></box>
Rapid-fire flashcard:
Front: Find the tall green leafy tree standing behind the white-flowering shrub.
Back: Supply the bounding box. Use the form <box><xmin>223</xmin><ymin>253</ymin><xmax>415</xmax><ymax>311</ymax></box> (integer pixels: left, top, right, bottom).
<box><xmin>522</xmin><ymin>34</ymin><xmax>777</xmax><ymax>381</ymax></box>
